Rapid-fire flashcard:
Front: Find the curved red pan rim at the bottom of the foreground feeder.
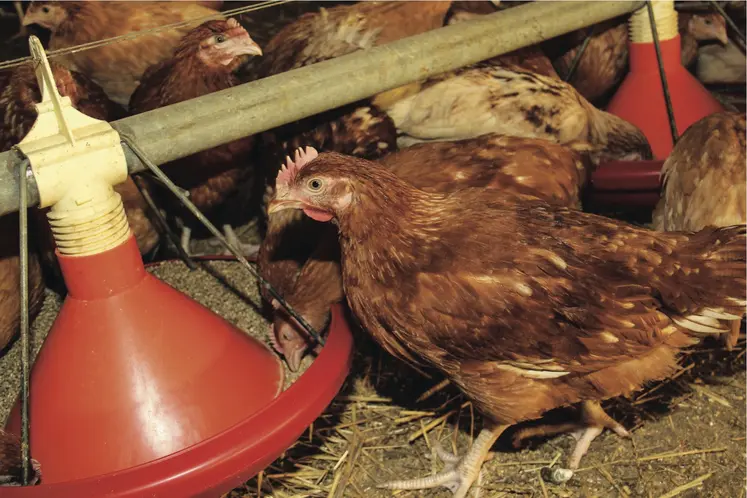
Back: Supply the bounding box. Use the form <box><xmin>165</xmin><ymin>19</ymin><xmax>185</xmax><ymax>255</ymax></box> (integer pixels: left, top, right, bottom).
<box><xmin>2</xmin><ymin>290</ymin><xmax>353</xmax><ymax>498</ymax></box>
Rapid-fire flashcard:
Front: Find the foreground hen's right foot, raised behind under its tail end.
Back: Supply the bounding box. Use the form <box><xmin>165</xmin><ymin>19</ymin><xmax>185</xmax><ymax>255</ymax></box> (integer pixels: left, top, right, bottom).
<box><xmin>513</xmin><ymin>401</ymin><xmax>630</xmax><ymax>484</ymax></box>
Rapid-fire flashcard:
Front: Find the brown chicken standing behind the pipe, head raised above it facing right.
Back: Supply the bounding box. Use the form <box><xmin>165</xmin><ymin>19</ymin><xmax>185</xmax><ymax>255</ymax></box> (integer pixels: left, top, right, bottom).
<box><xmin>130</xmin><ymin>19</ymin><xmax>262</xmax><ymax>254</ymax></box>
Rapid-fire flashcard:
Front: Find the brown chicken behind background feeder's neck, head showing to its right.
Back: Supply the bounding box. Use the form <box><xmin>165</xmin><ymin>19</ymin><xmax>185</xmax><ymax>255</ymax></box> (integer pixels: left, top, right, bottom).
<box><xmin>543</xmin><ymin>12</ymin><xmax>728</xmax><ymax>102</ymax></box>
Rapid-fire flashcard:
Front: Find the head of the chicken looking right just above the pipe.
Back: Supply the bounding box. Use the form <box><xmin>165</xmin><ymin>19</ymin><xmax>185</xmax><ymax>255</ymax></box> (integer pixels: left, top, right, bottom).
<box><xmin>193</xmin><ymin>19</ymin><xmax>262</xmax><ymax>69</ymax></box>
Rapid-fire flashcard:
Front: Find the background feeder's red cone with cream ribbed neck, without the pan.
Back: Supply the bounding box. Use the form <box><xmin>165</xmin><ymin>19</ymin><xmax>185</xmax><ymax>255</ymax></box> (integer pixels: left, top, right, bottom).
<box><xmin>607</xmin><ymin>0</ymin><xmax>723</xmax><ymax>160</ymax></box>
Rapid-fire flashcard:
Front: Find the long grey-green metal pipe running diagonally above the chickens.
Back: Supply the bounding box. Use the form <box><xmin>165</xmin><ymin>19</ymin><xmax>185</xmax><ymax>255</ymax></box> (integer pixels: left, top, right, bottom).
<box><xmin>0</xmin><ymin>1</ymin><xmax>645</xmax><ymax>215</ymax></box>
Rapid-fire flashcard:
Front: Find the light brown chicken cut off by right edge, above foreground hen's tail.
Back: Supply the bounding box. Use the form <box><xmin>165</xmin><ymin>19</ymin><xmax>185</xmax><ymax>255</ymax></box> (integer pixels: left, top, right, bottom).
<box><xmin>653</xmin><ymin>112</ymin><xmax>747</xmax><ymax>349</ymax></box>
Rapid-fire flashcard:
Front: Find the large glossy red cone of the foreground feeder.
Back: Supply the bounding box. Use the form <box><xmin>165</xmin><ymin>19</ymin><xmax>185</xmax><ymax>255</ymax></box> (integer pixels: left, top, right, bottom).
<box><xmin>8</xmin><ymin>234</ymin><xmax>283</xmax><ymax>484</ymax></box>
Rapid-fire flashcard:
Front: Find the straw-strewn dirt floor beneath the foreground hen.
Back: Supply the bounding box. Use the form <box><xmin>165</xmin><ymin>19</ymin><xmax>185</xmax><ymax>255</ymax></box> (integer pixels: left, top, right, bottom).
<box><xmin>229</xmin><ymin>326</ymin><xmax>745</xmax><ymax>498</ymax></box>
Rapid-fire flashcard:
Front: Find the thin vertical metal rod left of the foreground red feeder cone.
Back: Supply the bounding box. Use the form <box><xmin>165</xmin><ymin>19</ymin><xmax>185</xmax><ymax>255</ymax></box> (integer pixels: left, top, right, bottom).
<box><xmin>17</xmin><ymin>153</ymin><xmax>31</xmax><ymax>486</ymax></box>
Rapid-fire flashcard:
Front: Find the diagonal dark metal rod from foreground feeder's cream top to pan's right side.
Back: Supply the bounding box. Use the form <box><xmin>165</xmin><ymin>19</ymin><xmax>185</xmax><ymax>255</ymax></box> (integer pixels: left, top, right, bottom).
<box><xmin>120</xmin><ymin>133</ymin><xmax>325</xmax><ymax>346</ymax></box>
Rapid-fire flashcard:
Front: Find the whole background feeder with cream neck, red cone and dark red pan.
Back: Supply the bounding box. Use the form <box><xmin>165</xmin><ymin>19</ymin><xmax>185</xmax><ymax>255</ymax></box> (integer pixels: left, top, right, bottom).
<box><xmin>590</xmin><ymin>0</ymin><xmax>723</xmax><ymax>210</ymax></box>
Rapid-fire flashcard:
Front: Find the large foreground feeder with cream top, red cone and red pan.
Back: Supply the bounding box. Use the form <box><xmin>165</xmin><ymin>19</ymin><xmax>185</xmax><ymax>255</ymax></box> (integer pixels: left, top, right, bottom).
<box><xmin>3</xmin><ymin>36</ymin><xmax>352</xmax><ymax>497</ymax></box>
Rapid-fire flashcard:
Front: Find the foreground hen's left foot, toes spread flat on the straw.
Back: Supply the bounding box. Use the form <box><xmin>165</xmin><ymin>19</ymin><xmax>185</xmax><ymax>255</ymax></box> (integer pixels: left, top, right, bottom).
<box><xmin>378</xmin><ymin>425</ymin><xmax>508</xmax><ymax>498</ymax></box>
